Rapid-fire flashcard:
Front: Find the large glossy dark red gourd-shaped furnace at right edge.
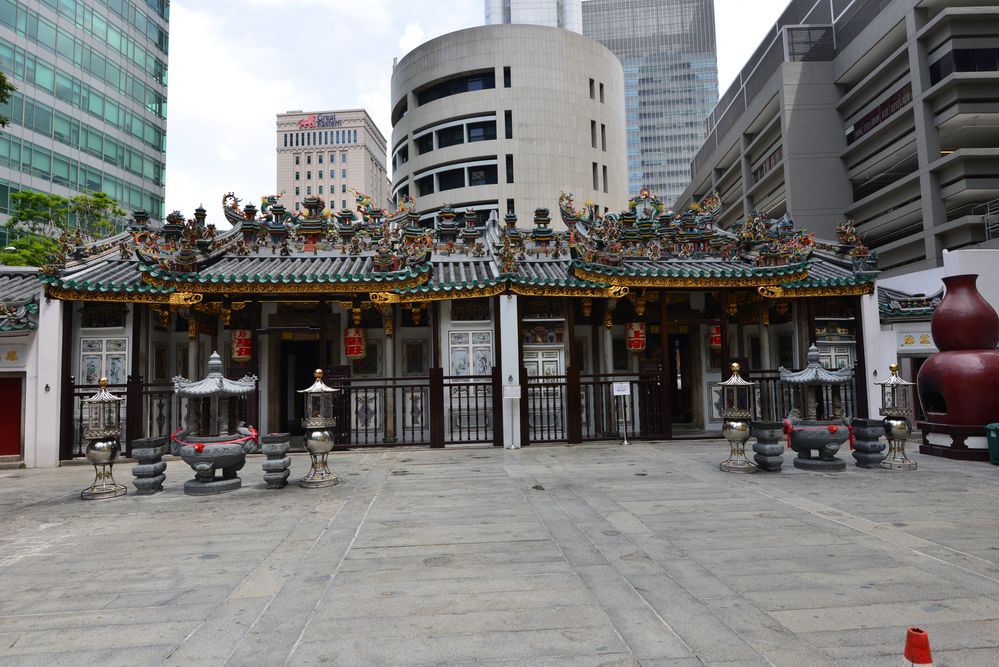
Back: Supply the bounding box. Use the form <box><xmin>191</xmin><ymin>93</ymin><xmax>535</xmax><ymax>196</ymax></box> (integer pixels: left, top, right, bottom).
<box><xmin>916</xmin><ymin>275</ymin><xmax>999</xmax><ymax>427</ymax></box>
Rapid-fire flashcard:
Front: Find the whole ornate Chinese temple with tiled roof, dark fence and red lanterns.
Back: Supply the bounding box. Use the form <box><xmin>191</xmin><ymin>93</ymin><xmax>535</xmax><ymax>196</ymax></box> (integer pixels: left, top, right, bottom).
<box><xmin>39</xmin><ymin>191</ymin><xmax>876</xmax><ymax>459</ymax></box>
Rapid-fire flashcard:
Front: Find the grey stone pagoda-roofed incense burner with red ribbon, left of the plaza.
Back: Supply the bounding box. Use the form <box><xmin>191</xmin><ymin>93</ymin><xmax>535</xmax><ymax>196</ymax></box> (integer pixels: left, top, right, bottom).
<box><xmin>171</xmin><ymin>352</ymin><xmax>257</xmax><ymax>495</ymax></box>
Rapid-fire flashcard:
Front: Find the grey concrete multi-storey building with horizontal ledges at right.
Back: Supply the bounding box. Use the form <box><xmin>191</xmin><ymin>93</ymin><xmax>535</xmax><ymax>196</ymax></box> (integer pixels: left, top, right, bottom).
<box><xmin>680</xmin><ymin>0</ymin><xmax>999</xmax><ymax>276</ymax></box>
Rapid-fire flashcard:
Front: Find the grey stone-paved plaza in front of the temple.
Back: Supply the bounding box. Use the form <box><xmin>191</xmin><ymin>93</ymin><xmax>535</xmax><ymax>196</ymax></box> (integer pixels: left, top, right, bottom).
<box><xmin>0</xmin><ymin>441</ymin><xmax>999</xmax><ymax>667</ymax></box>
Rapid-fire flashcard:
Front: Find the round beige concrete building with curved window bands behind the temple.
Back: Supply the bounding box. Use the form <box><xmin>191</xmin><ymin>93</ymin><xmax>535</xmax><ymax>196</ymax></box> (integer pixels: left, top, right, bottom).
<box><xmin>391</xmin><ymin>25</ymin><xmax>628</xmax><ymax>228</ymax></box>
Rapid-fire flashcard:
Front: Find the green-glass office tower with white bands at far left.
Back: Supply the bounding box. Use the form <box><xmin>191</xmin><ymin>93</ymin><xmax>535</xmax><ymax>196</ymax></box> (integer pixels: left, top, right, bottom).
<box><xmin>0</xmin><ymin>0</ymin><xmax>170</xmax><ymax>224</ymax></box>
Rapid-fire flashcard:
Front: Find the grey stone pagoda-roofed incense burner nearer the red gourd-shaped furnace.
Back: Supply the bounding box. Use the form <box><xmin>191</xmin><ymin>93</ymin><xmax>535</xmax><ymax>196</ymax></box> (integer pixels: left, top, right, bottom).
<box><xmin>780</xmin><ymin>345</ymin><xmax>853</xmax><ymax>472</ymax></box>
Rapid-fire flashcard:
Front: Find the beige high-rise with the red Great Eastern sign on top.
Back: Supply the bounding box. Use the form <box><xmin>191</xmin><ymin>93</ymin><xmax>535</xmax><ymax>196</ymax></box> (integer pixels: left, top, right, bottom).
<box><xmin>277</xmin><ymin>109</ymin><xmax>389</xmax><ymax>211</ymax></box>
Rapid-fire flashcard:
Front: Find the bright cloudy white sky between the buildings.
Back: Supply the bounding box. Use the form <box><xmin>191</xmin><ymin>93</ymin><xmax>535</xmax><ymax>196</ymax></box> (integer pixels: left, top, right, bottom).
<box><xmin>166</xmin><ymin>0</ymin><xmax>787</xmax><ymax>221</ymax></box>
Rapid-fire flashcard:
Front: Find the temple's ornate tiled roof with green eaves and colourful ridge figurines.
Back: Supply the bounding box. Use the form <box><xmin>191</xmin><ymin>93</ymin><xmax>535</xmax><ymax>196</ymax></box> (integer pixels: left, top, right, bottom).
<box><xmin>40</xmin><ymin>191</ymin><xmax>876</xmax><ymax>303</ymax></box>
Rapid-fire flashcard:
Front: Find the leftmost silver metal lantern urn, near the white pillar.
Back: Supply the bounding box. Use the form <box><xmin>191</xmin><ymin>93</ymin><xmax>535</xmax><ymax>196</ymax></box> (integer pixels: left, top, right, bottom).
<box><xmin>80</xmin><ymin>378</ymin><xmax>128</xmax><ymax>500</ymax></box>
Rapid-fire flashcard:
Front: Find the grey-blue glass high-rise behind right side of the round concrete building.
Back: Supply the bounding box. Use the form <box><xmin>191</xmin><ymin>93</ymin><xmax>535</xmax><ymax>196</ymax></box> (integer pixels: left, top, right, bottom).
<box><xmin>583</xmin><ymin>0</ymin><xmax>718</xmax><ymax>204</ymax></box>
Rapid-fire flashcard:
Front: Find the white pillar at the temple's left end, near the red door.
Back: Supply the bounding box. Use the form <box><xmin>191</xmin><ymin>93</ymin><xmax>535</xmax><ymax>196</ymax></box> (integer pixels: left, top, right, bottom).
<box><xmin>24</xmin><ymin>298</ymin><xmax>64</xmax><ymax>468</ymax></box>
